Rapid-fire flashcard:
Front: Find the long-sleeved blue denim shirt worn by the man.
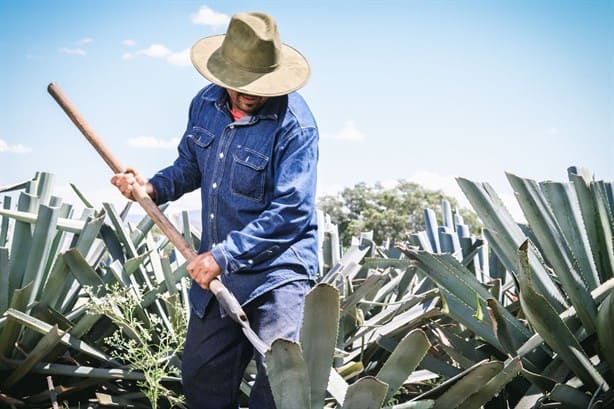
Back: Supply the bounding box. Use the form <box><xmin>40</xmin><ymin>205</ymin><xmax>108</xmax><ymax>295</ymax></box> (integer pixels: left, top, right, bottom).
<box><xmin>149</xmin><ymin>85</ymin><xmax>318</xmax><ymax>317</ymax></box>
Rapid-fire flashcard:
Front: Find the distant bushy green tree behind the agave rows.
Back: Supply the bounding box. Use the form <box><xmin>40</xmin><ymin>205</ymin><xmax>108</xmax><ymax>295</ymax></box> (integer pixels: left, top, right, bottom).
<box><xmin>318</xmin><ymin>180</ymin><xmax>480</xmax><ymax>247</ymax></box>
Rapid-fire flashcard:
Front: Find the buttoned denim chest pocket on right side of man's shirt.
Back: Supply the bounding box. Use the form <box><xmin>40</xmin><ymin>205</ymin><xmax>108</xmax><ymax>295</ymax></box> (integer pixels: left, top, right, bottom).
<box><xmin>230</xmin><ymin>148</ymin><xmax>269</xmax><ymax>201</ymax></box>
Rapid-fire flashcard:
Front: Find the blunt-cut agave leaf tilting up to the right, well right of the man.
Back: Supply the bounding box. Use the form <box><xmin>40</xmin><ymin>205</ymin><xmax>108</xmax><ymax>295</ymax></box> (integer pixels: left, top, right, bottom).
<box><xmin>376</xmin><ymin>329</ymin><xmax>431</xmax><ymax>401</ymax></box>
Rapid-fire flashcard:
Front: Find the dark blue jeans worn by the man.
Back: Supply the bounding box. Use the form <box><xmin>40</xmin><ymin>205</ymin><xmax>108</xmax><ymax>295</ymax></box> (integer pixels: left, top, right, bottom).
<box><xmin>182</xmin><ymin>280</ymin><xmax>311</xmax><ymax>409</ymax></box>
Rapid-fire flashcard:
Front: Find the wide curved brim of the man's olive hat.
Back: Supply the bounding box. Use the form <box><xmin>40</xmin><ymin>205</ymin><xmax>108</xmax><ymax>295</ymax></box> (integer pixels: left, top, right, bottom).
<box><xmin>190</xmin><ymin>35</ymin><xmax>311</xmax><ymax>97</ymax></box>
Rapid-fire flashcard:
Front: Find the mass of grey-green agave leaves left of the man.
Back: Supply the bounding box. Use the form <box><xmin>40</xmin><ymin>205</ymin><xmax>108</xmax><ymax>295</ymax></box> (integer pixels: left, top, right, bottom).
<box><xmin>0</xmin><ymin>172</ymin><xmax>191</xmax><ymax>407</ymax></box>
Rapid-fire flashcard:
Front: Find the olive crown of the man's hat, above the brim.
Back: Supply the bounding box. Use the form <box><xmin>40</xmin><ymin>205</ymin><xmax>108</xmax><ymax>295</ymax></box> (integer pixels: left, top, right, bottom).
<box><xmin>221</xmin><ymin>13</ymin><xmax>282</xmax><ymax>73</ymax></box>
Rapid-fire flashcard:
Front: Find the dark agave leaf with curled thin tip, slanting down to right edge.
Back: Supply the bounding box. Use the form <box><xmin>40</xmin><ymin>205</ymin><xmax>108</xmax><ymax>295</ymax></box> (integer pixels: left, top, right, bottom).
<box><xmin>519</xmin><ymin>240</ymin><xmax>607</xmax><ymax>389</ymax></box>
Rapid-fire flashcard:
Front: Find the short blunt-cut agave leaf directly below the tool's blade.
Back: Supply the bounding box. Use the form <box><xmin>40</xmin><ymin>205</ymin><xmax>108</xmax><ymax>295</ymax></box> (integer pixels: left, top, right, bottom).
<box><xmin>265</xmin><ymin>339</ymin><xmax>311</xmax><ymax>409</ymax></box>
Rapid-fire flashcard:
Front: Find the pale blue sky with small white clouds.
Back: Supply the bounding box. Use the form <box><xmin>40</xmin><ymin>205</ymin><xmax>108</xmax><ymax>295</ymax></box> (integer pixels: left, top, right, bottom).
<box><xmin>0</xmin><ymin>0</ymin><xmax>614</xmax><ymax>222</ymax></box>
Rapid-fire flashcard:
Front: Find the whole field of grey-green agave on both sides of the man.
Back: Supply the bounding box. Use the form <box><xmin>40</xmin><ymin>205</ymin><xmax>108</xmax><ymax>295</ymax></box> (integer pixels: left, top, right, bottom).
<box><xmin>0</xmin><ymin>168</ymin><xmax>614</xmax><ymax>409</ymax></box>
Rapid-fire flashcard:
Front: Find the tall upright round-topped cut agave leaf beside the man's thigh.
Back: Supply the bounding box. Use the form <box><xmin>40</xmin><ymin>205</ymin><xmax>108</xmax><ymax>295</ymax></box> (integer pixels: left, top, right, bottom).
<box><xmin>301</xmin><ymin>284</ymin><xmax>339</xmax><ymax>408</ymax></box>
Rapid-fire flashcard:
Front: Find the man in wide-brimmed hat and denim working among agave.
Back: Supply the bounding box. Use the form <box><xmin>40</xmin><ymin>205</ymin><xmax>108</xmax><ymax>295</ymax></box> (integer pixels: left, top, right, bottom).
<box><xmin>112</xmin><ymin>13</ymin><xmax>318</xmax><ymax>409</ymax></box>
